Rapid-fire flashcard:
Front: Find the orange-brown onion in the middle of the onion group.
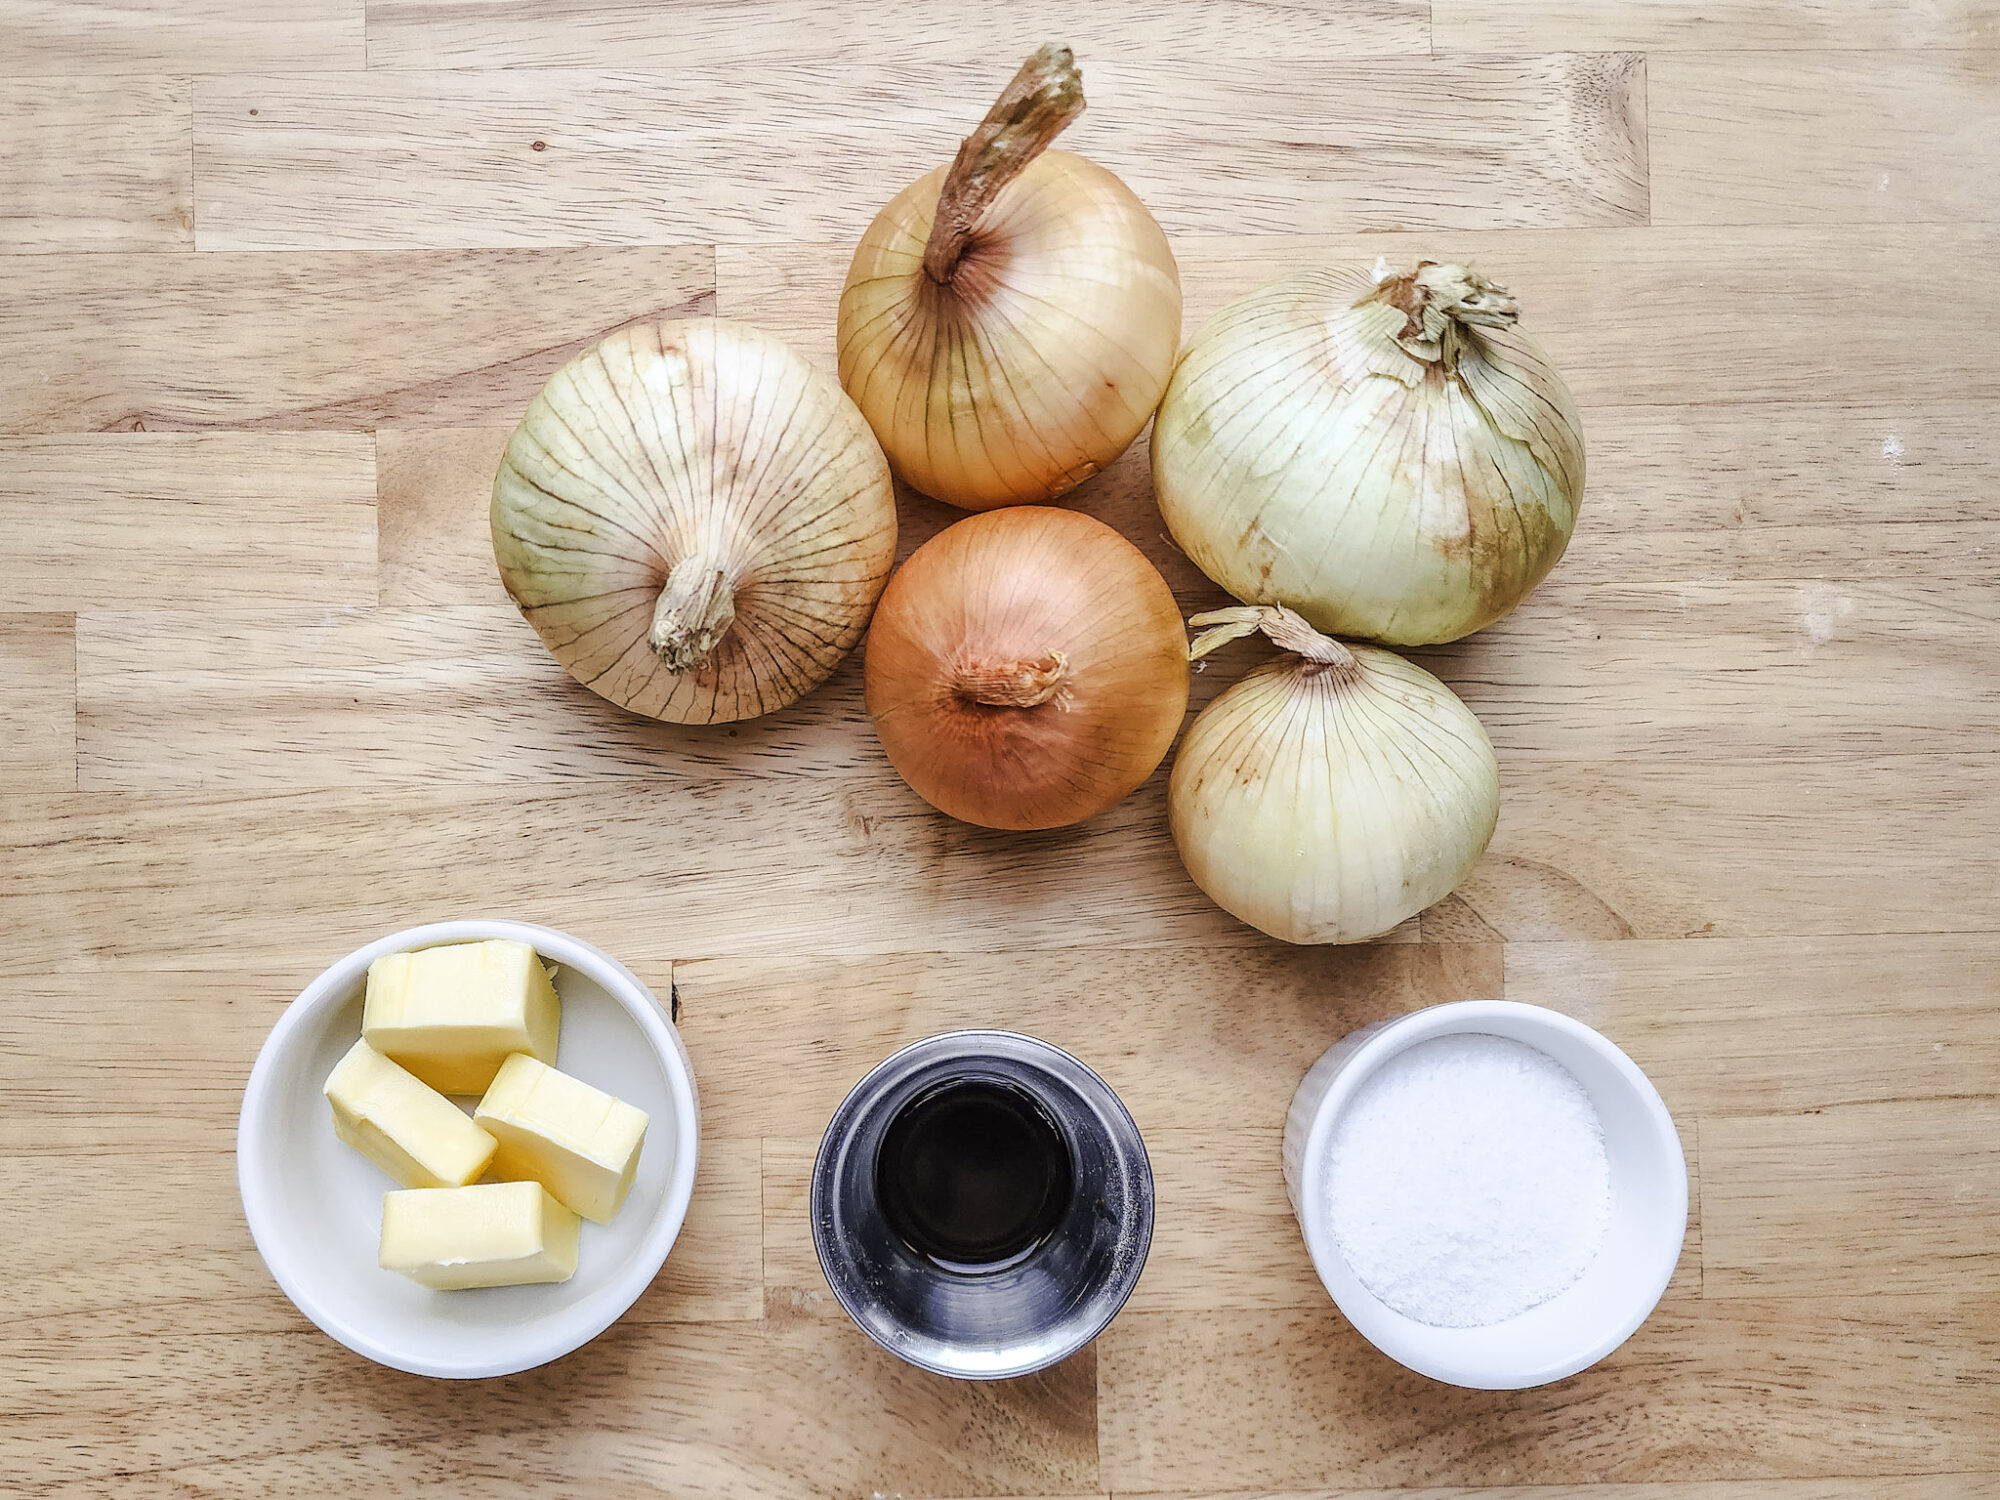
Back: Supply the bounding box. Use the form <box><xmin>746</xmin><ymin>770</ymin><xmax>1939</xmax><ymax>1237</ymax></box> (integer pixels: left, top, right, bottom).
<box><xmin>864</xmin><ymin>506</ymin><xmax>1188</xmax><ymax>828</ymax></box>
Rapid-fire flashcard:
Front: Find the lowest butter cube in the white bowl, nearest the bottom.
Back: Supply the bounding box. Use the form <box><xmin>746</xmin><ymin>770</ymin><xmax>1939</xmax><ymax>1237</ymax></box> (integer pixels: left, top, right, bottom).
<box><xmin>380</xmin><ymin>1182</ymin><xmax>578</xmax><ymax>1292</ymax></box>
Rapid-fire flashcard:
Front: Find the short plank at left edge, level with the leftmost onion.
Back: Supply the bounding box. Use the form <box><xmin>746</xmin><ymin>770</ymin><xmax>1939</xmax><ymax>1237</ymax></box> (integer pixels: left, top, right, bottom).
<box><xmin>0</xmin><ymin>432</ymin><xmax>376</xmax><ymax>622</ymax></box>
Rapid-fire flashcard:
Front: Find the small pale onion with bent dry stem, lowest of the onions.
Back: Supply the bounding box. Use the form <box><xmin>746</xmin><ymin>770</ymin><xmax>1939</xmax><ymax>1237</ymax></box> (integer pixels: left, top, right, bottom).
<box><xmin>1168</xmin><ymin>606</ymin><xmax>1500</xmax><ymax>942</ymax></box>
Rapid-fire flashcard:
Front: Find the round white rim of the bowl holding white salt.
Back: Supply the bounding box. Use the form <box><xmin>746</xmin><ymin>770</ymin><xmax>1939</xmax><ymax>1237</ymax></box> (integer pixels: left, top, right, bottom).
<box><xmin>1298</xmin><ymin>1000</ymin><xmax>1688</xmax><ymax>1390</ymax></box>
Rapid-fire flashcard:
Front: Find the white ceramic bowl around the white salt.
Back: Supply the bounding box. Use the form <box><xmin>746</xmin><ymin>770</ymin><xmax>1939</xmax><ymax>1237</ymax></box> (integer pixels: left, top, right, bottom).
<box><xmin>1284</xmin><ymin>1000</ymin><xmax>1688</xmax><ymax>1390</ymax></box>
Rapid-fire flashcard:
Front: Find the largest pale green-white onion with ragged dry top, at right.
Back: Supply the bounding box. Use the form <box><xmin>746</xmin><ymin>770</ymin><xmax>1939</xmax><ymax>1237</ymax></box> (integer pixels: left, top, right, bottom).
<box><xmin>1152</xmin><ymin>260</ymin><xmax>1584</xmax><ymax>646</ymax></box>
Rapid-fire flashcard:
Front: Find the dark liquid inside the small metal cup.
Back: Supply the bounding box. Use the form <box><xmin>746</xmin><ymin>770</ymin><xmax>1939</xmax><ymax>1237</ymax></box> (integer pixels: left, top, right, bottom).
<box><xmin>876</xmin><ymin>1082</ymin><xmax>1074</xmax><ymax>1266</ymax></box>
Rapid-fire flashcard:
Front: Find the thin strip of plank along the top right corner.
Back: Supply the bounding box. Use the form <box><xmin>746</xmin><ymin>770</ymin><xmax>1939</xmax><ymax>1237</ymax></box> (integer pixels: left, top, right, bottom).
<box><xmin>1432</xmin><ymin>0</ymin><xmax>2000</xmax><ymax>54</ymax></box>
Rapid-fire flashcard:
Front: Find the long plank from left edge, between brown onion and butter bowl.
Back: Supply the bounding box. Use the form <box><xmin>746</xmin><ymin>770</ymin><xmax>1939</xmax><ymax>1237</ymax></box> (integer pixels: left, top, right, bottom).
<box><xmin>0</xmin><ymin>778</ymin><xmax>1418</xmax><ymax>972</ymax></box>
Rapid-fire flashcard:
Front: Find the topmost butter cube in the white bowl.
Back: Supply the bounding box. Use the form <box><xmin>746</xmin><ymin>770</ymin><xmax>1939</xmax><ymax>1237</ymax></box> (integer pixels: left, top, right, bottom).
<box><xmin>362</xmin><ymin>938</ymin><xmax>562</xmax><ymax>1094</ymax></box>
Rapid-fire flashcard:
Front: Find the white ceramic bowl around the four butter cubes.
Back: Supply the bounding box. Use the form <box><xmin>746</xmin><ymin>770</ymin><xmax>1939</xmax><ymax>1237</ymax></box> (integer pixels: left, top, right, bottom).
<box><xmin>236</xmin><ymin>922</ymin><xmax>700</xmax><ymax>1380</ymax></box>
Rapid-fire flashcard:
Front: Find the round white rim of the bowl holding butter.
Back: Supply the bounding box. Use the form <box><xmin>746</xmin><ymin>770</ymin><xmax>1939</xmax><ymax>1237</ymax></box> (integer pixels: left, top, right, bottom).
<box><xmin>236</xmin><ymin>918</ymin><xmax>700</xmax><ymax>1380</ymax></box>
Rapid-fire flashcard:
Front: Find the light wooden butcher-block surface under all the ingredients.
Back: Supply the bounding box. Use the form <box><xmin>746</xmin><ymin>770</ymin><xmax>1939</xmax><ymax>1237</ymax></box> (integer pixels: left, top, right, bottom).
<box><xmin>0</xmin><ymin>0</ymin><xmax>2000</xmax><ymax>1500</ymax></box>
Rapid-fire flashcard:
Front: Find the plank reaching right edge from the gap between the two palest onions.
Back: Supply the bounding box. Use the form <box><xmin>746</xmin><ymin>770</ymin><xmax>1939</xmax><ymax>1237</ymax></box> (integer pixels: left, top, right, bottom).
<box><xmin>1416</xmin><ymin>574</ymin><xmax>2000</xmax><ymax>764</ymax></box>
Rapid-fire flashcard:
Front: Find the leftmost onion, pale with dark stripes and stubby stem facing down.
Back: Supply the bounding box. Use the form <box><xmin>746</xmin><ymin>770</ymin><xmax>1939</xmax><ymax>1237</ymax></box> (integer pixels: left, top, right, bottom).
<box><xmin>492</xmin><ymin>320</ymin><xmax>896</xmax><ymax>724</ymax></box>
